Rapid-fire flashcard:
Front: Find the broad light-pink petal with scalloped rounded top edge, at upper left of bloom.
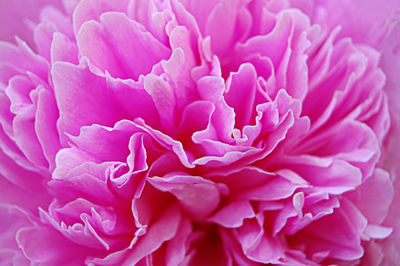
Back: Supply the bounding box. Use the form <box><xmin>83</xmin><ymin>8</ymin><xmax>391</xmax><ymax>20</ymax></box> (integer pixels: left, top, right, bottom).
<box><xmin>78</xmin><ymin>12</ymin><xmax>170</xmax><ymax>80</ymax></box>
